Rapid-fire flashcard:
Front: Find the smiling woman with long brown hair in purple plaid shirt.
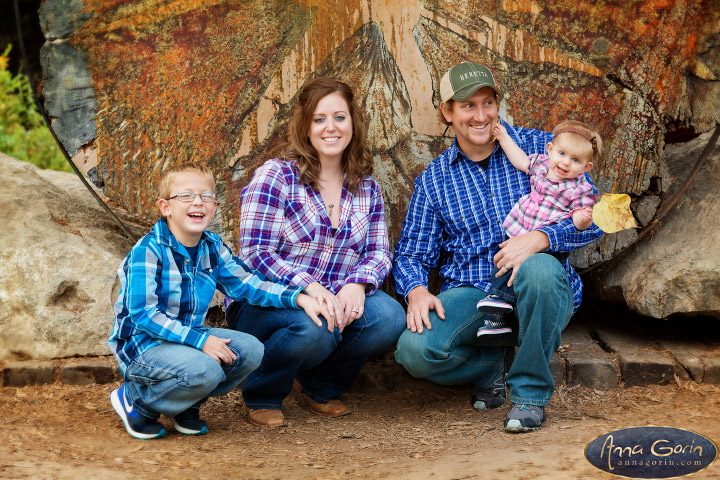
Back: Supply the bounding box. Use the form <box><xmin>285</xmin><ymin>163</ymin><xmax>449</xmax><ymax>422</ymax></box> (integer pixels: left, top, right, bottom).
<box><xmin>226</xmin><ymin>78</ymin><xmax>405</xmax><ymax>426</ymax></box>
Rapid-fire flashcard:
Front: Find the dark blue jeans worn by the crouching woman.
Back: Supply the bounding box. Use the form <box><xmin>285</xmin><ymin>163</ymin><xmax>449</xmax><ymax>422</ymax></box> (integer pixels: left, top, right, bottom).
<box><xmin>231</xmin><ymin>290</ymin><xmax>406</xmax><ymax>409</ymax></box>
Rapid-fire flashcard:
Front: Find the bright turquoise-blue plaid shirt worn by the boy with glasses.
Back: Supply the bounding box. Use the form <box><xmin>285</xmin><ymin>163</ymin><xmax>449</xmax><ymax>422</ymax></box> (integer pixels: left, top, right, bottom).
<box><xmin>108</xmin><ymin>219</ymin><xmax>302</xmax><ymax>373</ymax></box>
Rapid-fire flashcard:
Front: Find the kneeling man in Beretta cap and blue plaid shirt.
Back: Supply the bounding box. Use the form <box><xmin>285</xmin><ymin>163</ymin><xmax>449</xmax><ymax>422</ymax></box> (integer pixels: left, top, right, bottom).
<box><xmin>393</xmin><ymin>62</ymin><xmax>602</xmax><ymax>432</ymax></box>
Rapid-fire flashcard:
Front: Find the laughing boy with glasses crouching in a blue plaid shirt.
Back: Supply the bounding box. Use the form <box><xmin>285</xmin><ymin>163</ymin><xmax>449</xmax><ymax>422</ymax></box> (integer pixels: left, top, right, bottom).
<box><xmin>108</xmin><ymin>164</ymin><xmax>334</xmax><ymax>439</ymax></box>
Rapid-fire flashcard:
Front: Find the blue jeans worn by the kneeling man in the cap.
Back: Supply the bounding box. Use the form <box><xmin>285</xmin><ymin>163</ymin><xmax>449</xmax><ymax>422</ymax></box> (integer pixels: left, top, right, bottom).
<box><xmin>395</xmin><ymin>253</ymin><xmax>573</xmax><ymax>405</ymax></box>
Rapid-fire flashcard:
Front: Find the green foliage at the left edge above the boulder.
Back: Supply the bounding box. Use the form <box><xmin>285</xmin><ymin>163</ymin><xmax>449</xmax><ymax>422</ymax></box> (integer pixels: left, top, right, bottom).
<box><xmin>0</xmin><ymin>45</ymin><xmax>71</xmax><ymax>172</ymax></box>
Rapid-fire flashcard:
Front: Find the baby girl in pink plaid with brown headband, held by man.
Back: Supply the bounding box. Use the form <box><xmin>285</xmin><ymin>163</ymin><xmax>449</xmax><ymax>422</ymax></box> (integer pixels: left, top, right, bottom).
<box><xmin>477</xmin><ymin>120</ymin><xmax>602</xmax><ymax>336</ymax></box>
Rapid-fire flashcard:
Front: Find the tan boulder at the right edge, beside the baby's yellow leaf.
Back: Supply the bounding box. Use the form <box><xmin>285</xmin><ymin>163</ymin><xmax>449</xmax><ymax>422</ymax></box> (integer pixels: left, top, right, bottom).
<box><xmin>587</xmin><ymin>133</ymin><xmax>720</xmax><ymax>318</ymax></box>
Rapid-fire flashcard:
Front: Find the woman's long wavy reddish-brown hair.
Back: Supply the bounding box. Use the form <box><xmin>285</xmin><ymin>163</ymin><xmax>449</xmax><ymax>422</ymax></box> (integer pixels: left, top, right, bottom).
<box><xmin>272</xmin><ymin>78</ymin><xmax>372</xmax><ymax>193</ymax></box>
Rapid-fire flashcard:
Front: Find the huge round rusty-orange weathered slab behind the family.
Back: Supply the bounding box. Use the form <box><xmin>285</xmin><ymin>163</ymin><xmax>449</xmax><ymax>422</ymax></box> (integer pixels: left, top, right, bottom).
<box><xmin>40</xmin><ymin>0</ymin><xmax>720</xmax><ymax>258</ymax></box>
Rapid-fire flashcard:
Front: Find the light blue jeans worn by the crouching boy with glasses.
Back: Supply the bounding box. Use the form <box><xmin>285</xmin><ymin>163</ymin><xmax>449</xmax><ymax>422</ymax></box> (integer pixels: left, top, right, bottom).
<box><xmin>125</xmin><ymin>328</ymin><xmax>263</xmax><ymax>419</ymax></box>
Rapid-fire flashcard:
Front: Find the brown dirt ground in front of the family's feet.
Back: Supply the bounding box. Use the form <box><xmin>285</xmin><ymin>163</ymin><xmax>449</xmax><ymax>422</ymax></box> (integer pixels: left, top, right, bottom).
<box><xmin>0</xmin><ymin>381</ymin><xmax>720</xmax><ymax>480</ymax></box>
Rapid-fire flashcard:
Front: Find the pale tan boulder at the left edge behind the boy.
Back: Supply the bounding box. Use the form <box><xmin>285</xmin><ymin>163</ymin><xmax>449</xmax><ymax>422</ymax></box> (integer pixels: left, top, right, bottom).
<box><xmin>0</xmin><ymin>154</ymin><xmax>148</xmax><ymax>361</ymax></box>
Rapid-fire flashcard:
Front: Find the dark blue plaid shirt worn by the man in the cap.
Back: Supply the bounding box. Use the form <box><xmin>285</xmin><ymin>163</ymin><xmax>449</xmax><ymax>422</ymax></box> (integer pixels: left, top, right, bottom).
<box><xmin>393</xmin><ymin>120</ymin><xmax>602</xmax><ymax>311</ymax></box>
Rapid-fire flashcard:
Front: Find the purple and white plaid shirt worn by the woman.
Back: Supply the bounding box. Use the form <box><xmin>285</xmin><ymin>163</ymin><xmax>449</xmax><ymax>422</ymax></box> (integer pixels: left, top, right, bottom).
<box><xmin>238</xmin><ymin>159</ymin><xmax>392</xmax><ymax>295</ymax></box>
